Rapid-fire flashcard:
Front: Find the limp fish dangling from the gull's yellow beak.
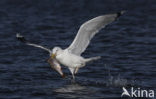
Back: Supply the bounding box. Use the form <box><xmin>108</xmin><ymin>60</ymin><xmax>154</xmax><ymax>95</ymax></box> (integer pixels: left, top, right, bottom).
<box><xmin>48</xmin><ymin>54</ymin><xmax>65</xmax><ymax>78</ymax></box>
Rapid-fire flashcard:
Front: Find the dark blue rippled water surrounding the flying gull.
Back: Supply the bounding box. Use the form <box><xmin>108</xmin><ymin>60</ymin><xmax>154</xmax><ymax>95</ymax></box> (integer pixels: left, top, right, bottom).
<box><xmin>0</xmin><ymin>0</ymin><xmax>156</xmax><ymax>99</ymax></box>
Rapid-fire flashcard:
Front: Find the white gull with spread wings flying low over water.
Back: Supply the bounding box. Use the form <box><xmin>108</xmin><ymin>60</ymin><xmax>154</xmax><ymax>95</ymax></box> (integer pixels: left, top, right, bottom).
<box><xmin>16</xmin><ymin>11</ymin><xmax>125</xmax><ymax>79</ymax></box>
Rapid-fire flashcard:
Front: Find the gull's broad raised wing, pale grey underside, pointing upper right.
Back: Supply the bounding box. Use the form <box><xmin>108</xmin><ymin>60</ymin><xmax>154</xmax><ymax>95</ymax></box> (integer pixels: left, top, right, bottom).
<box><xmin>67</xmin><ymin>11</ymin><xmax>124</xmax><ymax>55</ymax></box>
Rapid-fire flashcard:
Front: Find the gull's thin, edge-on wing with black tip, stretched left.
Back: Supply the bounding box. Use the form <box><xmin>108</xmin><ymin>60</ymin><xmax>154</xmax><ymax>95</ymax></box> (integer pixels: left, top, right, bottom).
<box><xmin>16</xmin><ymin>34</ymin><xmax>51</xmax><ymax>53</ymax></box>
